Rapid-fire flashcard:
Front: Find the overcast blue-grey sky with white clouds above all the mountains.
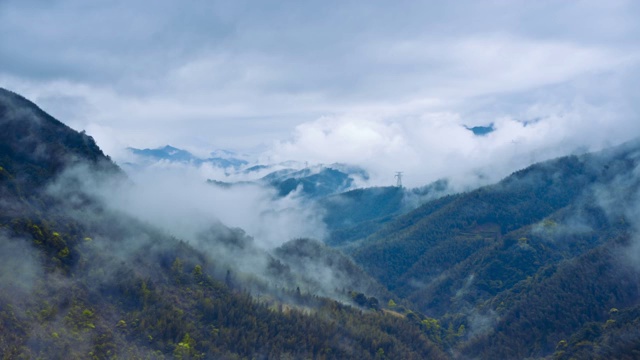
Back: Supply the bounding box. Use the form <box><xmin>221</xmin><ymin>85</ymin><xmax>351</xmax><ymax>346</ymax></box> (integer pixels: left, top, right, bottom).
<box><xmin>0</xmin><ymin>0</ymin><xmax>640</xmax><ymax>185</ymax></box>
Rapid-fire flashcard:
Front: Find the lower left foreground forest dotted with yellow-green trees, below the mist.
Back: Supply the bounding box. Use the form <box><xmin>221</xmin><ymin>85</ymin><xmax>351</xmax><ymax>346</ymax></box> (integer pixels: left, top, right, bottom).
<box><xmin>0</xmin><ymin>215</ymin><xmax>445</xmax><ymax>359</ymax></box>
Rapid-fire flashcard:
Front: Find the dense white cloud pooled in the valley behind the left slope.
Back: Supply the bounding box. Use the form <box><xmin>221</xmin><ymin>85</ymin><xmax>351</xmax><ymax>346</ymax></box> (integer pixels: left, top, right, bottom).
<box><xmin>80</xmin><ymin>162</ymin><xmax>325</xmax><ymax>249</ymax></box>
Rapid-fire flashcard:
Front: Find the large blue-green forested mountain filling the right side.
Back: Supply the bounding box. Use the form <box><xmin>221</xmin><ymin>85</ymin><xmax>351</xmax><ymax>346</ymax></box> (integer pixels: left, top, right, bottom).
<box><xmin>351</xmin><ymin>141</ymin><xmax>640</xmax><ymax>359</ymax></box>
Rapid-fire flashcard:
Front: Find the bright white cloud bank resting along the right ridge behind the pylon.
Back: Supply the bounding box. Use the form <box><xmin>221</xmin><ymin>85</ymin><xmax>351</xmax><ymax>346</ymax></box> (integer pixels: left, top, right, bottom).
<box><xmin>271</xmin><ymin>65</ymin><xmax>640</xmax><ymax>188</ymax></box>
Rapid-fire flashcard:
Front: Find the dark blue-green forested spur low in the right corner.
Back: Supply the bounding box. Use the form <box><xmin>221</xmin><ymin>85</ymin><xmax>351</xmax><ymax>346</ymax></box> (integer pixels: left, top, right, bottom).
<box><xmin>463</xmin><ymin>239</ymin><xmax>640</xmax><ymax>359</ymax></box>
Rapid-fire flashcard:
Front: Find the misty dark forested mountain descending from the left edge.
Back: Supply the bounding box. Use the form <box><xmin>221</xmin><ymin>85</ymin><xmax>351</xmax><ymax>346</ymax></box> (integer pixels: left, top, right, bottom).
<box><xmin>0</xmin><ymin>90</ymin><xmax>446</xmax><ymax>359</ymax></box>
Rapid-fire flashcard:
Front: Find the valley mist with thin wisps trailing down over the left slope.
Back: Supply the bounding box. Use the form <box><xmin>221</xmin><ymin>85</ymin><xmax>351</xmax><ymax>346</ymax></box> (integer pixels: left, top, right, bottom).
<box><xmin>42</xmin><ymin>162</ymin><xmax>396</xmax><ymax>308</ymax></box>
